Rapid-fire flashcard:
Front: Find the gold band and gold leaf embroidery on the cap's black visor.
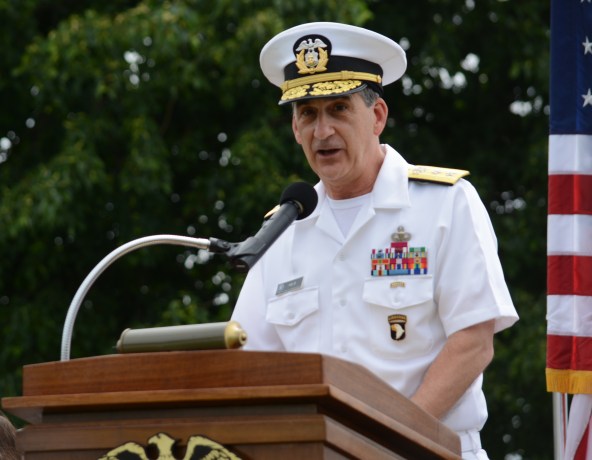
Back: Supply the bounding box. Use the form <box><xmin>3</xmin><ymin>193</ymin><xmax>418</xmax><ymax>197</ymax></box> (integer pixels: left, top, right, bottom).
<box><xmin>280</xmin><ymin>70</ymin><xmax>382</xmax><ymax>100</ymax></box>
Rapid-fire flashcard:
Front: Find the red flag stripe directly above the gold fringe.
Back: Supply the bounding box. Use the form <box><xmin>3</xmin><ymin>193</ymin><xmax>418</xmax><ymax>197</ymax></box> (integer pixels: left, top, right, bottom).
<box><xmin>547</xmin><ymin>335</ymin><xmax>592</xmax><ymax>371</ymax></box>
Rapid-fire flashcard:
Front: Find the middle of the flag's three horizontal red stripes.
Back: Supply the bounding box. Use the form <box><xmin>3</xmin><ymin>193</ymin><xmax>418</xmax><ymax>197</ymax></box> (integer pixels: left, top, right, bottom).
<box><xmin>547</xmin><ymin>256</ymin><xmax>592</xmax><ymax>296</ymax></box>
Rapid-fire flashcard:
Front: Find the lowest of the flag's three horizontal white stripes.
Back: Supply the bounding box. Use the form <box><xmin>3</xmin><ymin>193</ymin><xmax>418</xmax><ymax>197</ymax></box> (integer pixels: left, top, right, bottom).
<box><xmin>547</xmin><ymin>295</ymin><xmax>592</xmax><ymax>337</ymax></box>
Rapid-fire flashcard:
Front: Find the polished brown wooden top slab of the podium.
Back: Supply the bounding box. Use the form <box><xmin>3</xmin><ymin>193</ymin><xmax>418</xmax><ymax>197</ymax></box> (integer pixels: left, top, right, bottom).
<box><xmin>2</xmin><ymin>350</ymin><xmax>460</xmax><ymax>452</ymax></box>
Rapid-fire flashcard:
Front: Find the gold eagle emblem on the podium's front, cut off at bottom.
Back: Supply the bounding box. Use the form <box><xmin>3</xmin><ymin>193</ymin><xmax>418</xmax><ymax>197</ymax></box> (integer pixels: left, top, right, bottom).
<box><xmin>99</xmin><ymin>433</ymin><xmax>240</xmax><ymax>460</ymax></box>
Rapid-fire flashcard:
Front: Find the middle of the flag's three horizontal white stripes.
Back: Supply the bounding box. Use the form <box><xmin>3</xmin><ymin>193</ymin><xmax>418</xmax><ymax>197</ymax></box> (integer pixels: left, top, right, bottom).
<box><xmin>547</xmin><ymin>214</ymin><xmax>592</xmax><ymax>256</ymax></box>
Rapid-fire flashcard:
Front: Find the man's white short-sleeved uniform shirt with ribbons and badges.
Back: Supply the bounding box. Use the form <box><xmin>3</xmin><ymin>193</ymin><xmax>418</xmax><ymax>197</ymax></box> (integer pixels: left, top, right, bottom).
<box><xmin>233</xmin><ymin>146</ymin><xmax>518</xmax><ymax>431</ymax></box>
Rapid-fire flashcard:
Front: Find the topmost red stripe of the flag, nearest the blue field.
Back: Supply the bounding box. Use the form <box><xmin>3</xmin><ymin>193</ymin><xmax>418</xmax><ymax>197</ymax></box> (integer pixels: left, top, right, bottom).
<box><xmin>548</xmin><ymin>174</ymin><xmax>592</xmax><ymax>214</ymax></box>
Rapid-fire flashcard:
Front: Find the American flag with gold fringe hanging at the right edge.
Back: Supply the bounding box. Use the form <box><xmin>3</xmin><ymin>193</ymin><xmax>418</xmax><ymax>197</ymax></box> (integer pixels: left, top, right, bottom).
<box><xmin>546</xmin><ymin>0</ymin><xmax>592</xmax><ymax>460</ymax></box>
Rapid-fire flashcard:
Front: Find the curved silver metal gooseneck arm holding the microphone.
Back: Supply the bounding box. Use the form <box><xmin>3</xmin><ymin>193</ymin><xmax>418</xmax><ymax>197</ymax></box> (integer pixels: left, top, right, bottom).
<box><xmin>60</xmin><ymin>235</ymin><xmax>210</xmax><ymax>361</ymax></box>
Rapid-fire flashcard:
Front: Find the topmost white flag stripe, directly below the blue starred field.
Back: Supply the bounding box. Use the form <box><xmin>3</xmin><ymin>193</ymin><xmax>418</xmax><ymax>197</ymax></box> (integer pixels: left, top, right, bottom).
<box><xmin>549</xmin><ymin>134</ymin><xmax>592</xmax><ymax>174</ymax></box>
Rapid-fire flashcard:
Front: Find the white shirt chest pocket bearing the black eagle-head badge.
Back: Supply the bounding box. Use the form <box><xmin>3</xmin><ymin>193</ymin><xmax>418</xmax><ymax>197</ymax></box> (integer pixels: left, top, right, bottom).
<box><xmin>362</xmin><ymin>275</ymin><xmax>442</xmax><ymax>359</ymax></box>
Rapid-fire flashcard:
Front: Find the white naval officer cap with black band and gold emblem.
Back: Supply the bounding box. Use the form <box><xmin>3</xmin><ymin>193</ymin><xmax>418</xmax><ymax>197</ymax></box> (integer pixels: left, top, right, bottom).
<box><xmin>259</xmin><ymin>22</ymin><xmax>407</xmax><ymax>104</ymax></box>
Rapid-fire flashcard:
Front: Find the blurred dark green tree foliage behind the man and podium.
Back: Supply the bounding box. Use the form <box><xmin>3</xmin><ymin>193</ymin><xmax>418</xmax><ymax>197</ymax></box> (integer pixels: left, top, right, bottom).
<box><xmin>0</xmin><ymin>0</ymin><xmax>552</xmax><ymax>459</ymax></box>
